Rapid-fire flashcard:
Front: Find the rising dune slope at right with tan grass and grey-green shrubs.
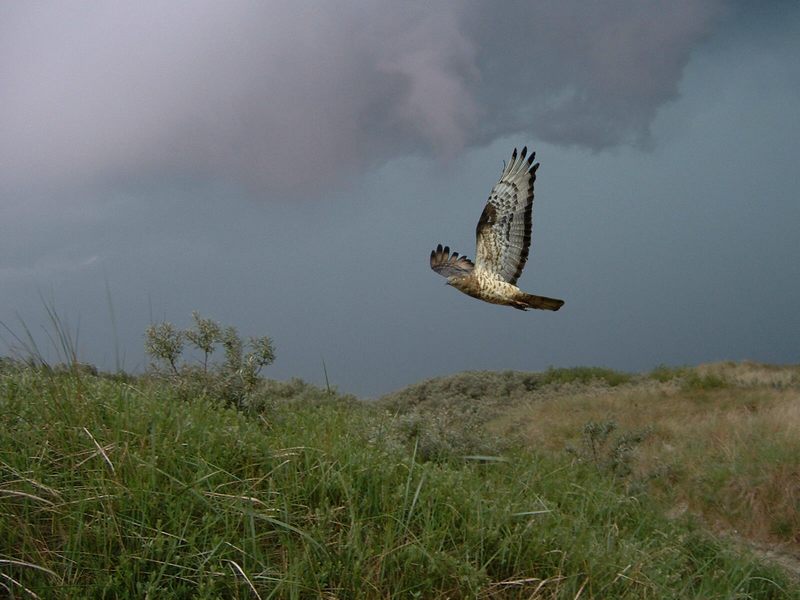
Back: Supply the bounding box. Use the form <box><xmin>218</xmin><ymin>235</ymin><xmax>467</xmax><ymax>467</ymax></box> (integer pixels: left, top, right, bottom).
<box><xmin>379</xmin><ymin>362</ymin><xmax>800</xmax><ymax>564</ymax></box>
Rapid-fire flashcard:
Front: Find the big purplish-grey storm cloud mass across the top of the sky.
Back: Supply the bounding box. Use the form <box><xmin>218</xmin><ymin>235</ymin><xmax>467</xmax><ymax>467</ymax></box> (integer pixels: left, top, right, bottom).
<box><xmin>0</xmin><ymin>0</ymin><xmax>718</xmax><ymax>197</ymax></box>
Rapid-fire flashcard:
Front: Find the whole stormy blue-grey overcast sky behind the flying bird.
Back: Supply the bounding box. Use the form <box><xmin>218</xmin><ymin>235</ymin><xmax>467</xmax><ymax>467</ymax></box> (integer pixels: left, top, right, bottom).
<box><xmin>0</xmin><ymin>0</ymin><xmax>800</xmax><ymax>397</ymax></box>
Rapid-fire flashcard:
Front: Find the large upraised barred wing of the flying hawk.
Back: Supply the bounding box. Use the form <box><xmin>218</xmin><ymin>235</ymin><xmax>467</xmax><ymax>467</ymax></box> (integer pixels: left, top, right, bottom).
<box><xmin>475</xmin><ymin>146</ymin><xmax>539</xmax><ymax>284</ymax></box>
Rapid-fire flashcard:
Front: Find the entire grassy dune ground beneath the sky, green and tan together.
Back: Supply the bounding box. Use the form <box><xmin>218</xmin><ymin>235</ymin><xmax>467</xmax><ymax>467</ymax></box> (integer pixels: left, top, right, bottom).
<box><xmin>0</xmin><ymin>368</ymin><xmax>800</xmax><ymax>599</ymax></box>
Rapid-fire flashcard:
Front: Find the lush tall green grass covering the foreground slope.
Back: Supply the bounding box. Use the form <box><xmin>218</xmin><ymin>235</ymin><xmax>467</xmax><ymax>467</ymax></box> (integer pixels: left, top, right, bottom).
<box><xmin>0</xmin><ymin>369</ymin><xmax>800</xmax><ymax>599</ymax></box>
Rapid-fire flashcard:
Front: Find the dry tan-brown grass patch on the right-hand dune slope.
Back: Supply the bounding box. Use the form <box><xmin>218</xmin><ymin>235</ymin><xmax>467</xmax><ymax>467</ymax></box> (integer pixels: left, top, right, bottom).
<box><xmin>489</xmin><ymin>370</ymin><xmax>800</xmax><ymax>551</ymax></box>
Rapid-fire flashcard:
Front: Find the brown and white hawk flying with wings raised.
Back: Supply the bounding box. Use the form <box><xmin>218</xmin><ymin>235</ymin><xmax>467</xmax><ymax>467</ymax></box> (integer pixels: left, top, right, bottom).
<box><xmin>431</xmin><ymin>146</ymin><xmax>564</xmax><ymax>310</ymax></box>
